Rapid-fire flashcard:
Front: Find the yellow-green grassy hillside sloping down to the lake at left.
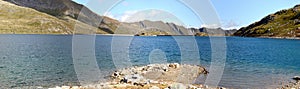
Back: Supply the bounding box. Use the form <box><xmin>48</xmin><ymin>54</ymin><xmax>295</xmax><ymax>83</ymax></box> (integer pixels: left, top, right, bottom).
<box><xmin>0</xmin><ymin>0</ymin><xmax>105</xmax><ymax>34</ymax></box>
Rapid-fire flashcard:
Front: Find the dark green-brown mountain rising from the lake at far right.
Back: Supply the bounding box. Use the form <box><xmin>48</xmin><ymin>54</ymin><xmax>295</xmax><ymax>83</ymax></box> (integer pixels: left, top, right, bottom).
<box><xmin>234</xmin><ymin>5</ymin><xmax>300</xmax><ymax>37</ymax></box>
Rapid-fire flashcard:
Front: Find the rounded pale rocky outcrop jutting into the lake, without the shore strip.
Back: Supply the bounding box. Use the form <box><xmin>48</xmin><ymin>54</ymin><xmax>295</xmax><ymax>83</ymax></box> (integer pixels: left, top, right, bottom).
<box><xmin>112</xmin><ymin>63</ymin><xmax>208</xmax><ymax>84</ymax></box>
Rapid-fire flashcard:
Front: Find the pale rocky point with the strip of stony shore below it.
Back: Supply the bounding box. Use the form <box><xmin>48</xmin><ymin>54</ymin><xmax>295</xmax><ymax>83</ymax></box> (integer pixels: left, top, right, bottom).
<box><xmin>49</xmin><ymin>63</ymin><xmax>225</xmax><ymax>89</ymax></box>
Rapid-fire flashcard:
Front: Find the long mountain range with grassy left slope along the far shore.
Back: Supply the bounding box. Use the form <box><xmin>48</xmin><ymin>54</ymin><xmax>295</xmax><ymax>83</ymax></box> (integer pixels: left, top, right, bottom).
<box><xmin>0</xmin><ymin>0</ymin><xmax>236</xmax><ymax>36</ymax></box>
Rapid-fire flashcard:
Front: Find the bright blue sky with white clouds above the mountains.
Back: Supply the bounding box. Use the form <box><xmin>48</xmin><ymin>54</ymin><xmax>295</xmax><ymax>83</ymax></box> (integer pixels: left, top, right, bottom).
<box><xmin>73</xmin><ymin>0</ymin><xmax>300</xmax><ymax>29</ymax></box>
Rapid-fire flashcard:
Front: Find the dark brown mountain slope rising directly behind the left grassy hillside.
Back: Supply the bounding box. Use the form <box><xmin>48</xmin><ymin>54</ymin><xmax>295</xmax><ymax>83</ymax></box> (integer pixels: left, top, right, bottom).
<box><xmin>4</xmin><ymin>0</ymin><xmax>119</xmax><ymax>34</ymax></box>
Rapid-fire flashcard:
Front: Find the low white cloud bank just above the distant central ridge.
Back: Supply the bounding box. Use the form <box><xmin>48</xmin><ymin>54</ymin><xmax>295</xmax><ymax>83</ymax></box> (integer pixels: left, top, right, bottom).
<box><xmin>104</xmin><ymin>9</ymin><xmax>241</xmax><ymax>30</ymax></box>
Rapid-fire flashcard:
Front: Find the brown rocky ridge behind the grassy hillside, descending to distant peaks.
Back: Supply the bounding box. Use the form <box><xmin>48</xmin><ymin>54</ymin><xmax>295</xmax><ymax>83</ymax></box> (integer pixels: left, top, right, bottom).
<box><xmin>3</xmin><ymin>0</ymin><xmax>237</xmax><ymax>36</ymax></box>
